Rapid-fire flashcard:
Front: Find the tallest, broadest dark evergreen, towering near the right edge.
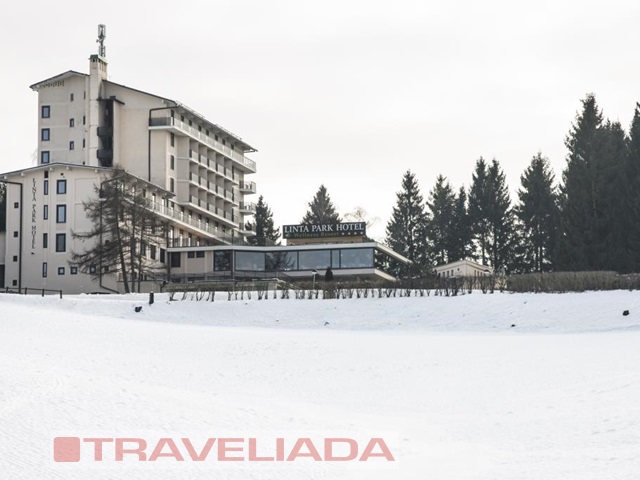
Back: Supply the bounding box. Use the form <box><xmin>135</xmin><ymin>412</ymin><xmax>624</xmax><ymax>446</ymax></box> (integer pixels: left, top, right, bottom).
<box><xmin>558</xmin><ymin>95</ymin><xmax>635</xmax><ymax>270</ymax></box>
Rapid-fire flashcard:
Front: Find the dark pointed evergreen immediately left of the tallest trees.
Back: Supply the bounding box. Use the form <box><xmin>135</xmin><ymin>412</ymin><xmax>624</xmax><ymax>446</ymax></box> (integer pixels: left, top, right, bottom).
<box><xmin>515</xmin><ymin>153</ymin><xmax>559</xmax><ymax>272</ymax></box>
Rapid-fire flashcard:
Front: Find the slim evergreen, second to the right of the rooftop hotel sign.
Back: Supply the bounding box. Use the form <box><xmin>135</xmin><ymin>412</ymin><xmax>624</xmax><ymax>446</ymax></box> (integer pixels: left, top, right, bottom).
<box><xmin>427</xmin><ymin>175</ymin><xmax>456</xmax><ymax>265</ymax></box>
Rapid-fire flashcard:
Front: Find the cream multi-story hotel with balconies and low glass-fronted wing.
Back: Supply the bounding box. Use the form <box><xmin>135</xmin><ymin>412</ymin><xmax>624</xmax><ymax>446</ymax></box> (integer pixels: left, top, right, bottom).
<box><xmin>0</xmin><ymin>31</ymin><xmax>406</xmax><ymax>293</ymax></box>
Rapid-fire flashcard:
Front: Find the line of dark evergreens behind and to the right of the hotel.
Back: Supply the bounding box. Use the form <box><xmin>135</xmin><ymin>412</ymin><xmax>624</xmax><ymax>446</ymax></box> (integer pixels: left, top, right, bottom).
<box><xmin>251</xmin><ymin>94</ymin><xmax>640</xmax><ymax>276</ymax></box>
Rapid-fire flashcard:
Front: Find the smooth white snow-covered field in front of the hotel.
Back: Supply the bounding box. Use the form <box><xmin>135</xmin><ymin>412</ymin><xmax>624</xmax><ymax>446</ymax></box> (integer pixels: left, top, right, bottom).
<box><xmin>0</xmin><ymin>291</ymin><xmax>640</xmax><ymax>480</ymax></box>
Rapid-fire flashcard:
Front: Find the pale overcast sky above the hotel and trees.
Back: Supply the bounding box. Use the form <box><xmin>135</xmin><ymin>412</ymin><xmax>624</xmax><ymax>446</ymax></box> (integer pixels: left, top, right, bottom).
<box><xmin>0</xmin><ymin>0</ymin><xmax>640</xmax><ymax>238</ymax></box>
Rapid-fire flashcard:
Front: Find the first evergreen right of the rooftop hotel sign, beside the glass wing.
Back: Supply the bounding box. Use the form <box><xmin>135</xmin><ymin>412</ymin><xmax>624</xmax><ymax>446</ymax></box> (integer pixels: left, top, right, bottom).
<box><xmin>387</xmin><ymin>171</ymin><xmax>432</xmax><ymax>277</ymax></box>
